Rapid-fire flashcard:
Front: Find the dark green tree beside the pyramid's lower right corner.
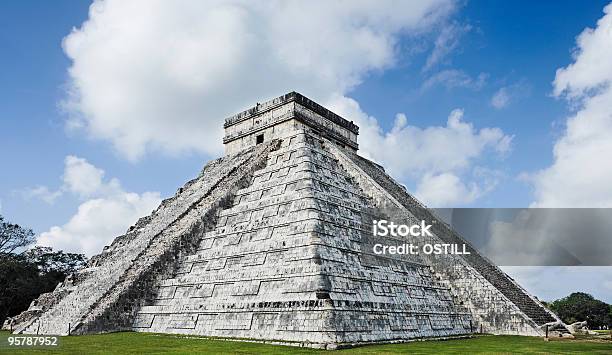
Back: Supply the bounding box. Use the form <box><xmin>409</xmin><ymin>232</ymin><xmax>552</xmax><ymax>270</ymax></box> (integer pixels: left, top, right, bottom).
<box><xmin>550</xmin><ymin>292</ymin><xmax>612</xmax><ymax>329</ymax></box>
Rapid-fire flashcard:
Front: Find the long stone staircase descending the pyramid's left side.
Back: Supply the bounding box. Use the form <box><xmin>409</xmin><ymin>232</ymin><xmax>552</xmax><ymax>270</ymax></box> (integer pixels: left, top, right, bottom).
<box><xmin>14</xmin><ymin>142</ymin><xmax>278</xmax><ymax>335</ymax></box>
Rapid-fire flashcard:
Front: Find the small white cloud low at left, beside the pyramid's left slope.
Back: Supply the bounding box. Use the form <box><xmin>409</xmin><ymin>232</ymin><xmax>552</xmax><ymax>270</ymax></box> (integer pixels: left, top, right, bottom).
<box><xmin>37</xmin><ymin>156</ymin><xmax>161</xmax><ymax>256</ymax></box>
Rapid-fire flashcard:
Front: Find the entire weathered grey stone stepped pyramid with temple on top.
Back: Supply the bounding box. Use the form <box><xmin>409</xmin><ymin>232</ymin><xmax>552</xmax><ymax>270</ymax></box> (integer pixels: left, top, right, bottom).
<box><xmin>12</xmin><ymin>92</ymin><xmax>560</xmax><ymax>349</ymax></box>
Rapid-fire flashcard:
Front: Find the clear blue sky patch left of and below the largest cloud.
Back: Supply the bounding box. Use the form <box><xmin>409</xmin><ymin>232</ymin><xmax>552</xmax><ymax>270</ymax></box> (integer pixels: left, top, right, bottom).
<box><xmin>0</xmin><ymin>0</ymin><xmax>204</xmax><ymax>232</ymax></box>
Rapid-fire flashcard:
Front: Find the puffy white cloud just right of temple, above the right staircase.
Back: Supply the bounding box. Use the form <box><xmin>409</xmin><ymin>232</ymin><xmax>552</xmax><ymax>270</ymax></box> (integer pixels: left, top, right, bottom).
<box><xmin>328</xmin><ymin>97</ymin><xmax>513</xmax><ymax>207</ymax></box>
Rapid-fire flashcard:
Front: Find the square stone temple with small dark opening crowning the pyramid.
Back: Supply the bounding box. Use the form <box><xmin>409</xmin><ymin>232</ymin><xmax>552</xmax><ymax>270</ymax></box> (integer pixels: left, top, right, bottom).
<box><xmin>223</xmin><ymin>91</ymin><xmax>359</xmax><ymax>155</ymax></box>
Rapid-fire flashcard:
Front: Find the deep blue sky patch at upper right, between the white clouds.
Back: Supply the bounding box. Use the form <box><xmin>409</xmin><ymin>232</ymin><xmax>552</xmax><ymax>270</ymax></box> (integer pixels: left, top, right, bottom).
<box><xmin>351</xmin><ymin>1</ymin><xmax>606</xmax><ymax>207</ymax></box>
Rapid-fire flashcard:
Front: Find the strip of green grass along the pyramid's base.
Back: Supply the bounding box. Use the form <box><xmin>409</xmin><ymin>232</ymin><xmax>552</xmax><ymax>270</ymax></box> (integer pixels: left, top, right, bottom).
<box><xmin>0</xmin><ymin>332</ymin><xmax>612</xmax><ymax>355</ymax></box>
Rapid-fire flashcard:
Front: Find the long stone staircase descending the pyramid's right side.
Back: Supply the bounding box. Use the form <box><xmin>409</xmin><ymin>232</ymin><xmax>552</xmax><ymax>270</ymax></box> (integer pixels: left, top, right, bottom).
<box><xmin>331</xmin><ymin>147</ymin><xmax>559</xmax><ymax>335</ymax></box>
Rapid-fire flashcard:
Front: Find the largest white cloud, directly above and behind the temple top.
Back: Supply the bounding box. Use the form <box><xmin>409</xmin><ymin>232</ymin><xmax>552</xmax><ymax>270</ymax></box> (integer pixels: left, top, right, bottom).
<box><xmin>63</xmin><ymin>0</ymin><xmax>454</xmax><ymax>160</ymax></box>
